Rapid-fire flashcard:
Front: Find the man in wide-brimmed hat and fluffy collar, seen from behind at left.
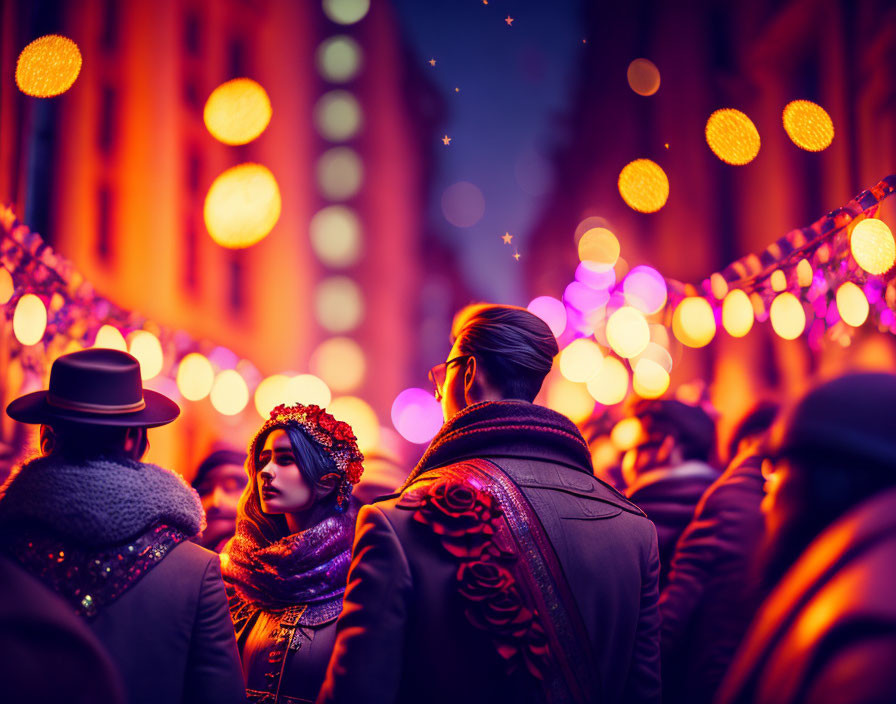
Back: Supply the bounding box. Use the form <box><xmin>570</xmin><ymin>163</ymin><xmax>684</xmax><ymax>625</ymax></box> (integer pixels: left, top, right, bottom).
<box><xmin>0</xmin><ymin>349</ymin><xmax>245</xmax><ymax>703</ymax></box>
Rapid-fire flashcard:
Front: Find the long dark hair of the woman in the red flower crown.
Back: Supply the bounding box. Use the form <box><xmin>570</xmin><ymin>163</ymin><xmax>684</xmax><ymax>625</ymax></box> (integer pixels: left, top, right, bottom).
<box><xmin>237</xmin><ymin>423</ymin><xmax>336</xmax><ymax>543</ymax></box>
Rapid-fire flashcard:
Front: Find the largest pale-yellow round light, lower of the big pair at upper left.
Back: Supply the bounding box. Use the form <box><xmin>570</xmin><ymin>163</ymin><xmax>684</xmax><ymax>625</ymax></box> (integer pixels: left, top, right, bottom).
<box><xmin>203</xmin><ymin>164</ymin><xmax>280</xmax><ymax>249</ymax></box>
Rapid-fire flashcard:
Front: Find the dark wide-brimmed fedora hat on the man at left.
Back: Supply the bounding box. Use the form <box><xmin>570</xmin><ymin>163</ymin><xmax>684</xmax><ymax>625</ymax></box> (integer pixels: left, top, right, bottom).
<box><xmin>6</xmin><ymin>349</ymin><xmax>180</xmax><ymax>428</ymax></box>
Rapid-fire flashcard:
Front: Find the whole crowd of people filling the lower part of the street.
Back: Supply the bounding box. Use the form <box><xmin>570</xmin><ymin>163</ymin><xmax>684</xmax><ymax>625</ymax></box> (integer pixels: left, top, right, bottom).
<box><xmin>0</xmin><ymin>305</ymin><xmax>896</xmax><ymax>704</ymax></box>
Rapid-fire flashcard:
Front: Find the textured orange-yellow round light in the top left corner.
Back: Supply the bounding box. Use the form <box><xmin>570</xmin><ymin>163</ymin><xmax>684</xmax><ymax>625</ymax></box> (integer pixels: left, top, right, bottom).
<box><xmin>16</xmin><ymin>34</ymin><xmax>81</xmax><ymax>98</ymax></box>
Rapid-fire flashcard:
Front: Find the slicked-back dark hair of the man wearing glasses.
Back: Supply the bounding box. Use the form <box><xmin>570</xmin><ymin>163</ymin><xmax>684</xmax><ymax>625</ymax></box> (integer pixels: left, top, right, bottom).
<box><xmin>452</xmin><ymin>303</ymin><xmax>559</xmax><ymax>401</ymax></box>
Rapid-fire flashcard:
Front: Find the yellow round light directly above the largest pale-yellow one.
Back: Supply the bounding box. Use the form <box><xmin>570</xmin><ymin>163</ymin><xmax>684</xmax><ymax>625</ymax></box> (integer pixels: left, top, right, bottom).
<box><xmin>202</xmin><ymin>78</ymin><xmax>271</xmax><ymax>145</ymax></box>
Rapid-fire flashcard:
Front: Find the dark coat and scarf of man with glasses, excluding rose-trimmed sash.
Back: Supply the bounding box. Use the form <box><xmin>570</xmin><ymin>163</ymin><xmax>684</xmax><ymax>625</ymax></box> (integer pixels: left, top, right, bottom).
<box><xmin>318</xmin><ymin>401</ymin><xmax>660</xmax><ymax>704</ymax></box>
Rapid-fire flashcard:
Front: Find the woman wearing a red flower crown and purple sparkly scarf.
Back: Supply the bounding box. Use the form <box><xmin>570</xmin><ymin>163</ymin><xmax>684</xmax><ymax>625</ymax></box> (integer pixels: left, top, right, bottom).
<box><xmin>221</xmin><ymin>405</ymin><xmax>363</xmax><ymax>704</ymax></box>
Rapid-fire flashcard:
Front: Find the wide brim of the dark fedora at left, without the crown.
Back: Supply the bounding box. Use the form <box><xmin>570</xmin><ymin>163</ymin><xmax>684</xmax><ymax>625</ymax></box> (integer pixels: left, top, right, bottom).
<box><xmin>6</xmin><ymin>389</ymin><xmax>180</xmax><ymax>428</ymax></box>
